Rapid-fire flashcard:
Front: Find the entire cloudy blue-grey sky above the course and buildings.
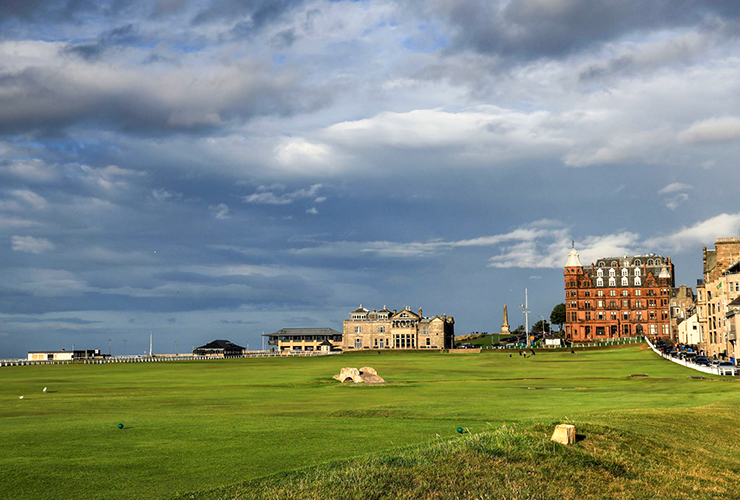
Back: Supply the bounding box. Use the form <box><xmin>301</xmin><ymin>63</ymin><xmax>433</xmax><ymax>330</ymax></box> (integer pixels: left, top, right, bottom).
<box><xmin>0</xmin><ymin>0</ymin><xmax>740</xmax><ymax>357</ymax></box>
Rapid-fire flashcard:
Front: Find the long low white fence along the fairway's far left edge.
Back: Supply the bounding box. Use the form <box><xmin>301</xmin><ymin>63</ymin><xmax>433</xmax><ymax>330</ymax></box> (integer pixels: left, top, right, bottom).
<box><xmin>0</xmin><ymin>351</ymin><xmax>342</xmax><ymax>367</ymax></box>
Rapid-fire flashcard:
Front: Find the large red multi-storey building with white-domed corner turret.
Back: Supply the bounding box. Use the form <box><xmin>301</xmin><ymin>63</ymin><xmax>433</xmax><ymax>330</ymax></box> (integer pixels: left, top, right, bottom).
<box><xmin>564</xmin><ymin>248</ymin><xmax>674</xmax><ymax>342</ymax></box>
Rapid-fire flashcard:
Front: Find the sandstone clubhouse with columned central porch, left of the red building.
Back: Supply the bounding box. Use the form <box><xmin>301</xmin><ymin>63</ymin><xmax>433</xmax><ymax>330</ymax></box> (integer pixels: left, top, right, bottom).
<box><xmin>342</xmin><ymin>305</ymin><xmax>455</xmax><ymax>351</ymax></box>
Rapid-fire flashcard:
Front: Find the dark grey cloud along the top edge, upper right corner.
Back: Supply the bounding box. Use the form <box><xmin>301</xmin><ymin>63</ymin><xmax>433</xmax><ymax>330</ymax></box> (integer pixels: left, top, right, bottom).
<box><xmin>424</xmin><ymin>0</ymin><xmax>740</xmax><ymax>59</ymax></box>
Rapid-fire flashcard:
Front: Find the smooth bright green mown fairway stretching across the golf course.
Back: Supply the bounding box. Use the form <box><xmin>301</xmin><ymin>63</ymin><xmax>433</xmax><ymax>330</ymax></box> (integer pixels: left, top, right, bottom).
<box><xmin>0</xmin><ymin>347</ymin><xmax>740</xmax><ymax>499</ymax></box>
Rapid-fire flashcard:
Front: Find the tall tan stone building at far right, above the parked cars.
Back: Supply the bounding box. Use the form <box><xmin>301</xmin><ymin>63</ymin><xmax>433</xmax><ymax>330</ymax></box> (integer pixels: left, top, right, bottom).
<box><xmin>696</xmin><ymin>238</ymin><xmax>740</xmax><ymax>359</ymax></box>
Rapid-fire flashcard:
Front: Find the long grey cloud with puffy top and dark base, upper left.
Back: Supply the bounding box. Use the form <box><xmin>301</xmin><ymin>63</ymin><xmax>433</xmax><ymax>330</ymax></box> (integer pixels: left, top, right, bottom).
<box><xmin>0</xmin><ymin>62</ymin><xmax>329</xmax><ymax>134</ymax></box>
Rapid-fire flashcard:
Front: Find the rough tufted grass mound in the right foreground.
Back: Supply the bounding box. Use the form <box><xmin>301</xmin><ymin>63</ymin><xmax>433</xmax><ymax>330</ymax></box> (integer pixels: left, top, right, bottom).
<box><xmin>182</xmin><ymin>409</ymin><xmax>740</xmax><ymax>500</ymax></box>
